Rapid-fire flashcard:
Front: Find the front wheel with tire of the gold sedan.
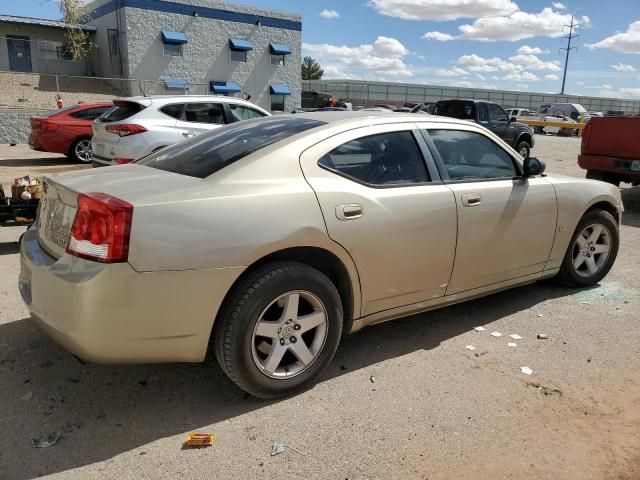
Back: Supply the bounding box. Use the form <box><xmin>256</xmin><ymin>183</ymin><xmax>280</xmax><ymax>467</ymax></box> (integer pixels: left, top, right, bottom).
<box><xmin>558</xmin><ymin>210</ymin><xmax>620</xmax><ymax>287</ymax></box>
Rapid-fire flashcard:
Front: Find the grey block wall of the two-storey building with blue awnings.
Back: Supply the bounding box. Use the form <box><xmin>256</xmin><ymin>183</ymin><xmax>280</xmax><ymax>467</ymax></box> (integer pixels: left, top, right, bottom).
<box><xmin>86</xmin><ymin>0</ymin><xmax>302</xmax><ymax>111</ymax></box>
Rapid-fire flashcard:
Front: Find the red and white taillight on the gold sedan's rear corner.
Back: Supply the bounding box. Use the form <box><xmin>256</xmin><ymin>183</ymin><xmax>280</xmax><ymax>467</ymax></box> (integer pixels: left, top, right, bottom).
<box><xmin>67</xmin><ymin>193</ymin><xmax>133</xmax><ymax>263</ymax></box>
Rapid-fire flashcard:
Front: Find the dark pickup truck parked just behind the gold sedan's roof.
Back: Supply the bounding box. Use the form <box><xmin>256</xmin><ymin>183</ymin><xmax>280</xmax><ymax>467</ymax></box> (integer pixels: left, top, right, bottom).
<box><xmin>433</xmin><ymin>100</ymin><xmax>534</xmax><ymax>158</ymax></box>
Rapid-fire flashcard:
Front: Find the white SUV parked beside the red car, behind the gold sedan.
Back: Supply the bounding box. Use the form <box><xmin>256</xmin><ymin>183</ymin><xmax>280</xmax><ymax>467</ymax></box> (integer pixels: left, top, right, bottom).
<box><xmin>91</xmin><ymin>95</ymin><xmax>271</xmax><ymax>167</ymax></box>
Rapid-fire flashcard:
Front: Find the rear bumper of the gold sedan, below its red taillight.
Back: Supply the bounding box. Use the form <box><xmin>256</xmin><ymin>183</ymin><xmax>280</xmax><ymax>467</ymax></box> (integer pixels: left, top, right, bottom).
<box><xmin>19</xmin><ymin>229</ymin><xmax>243</xmax><ymax>363</ymax></box>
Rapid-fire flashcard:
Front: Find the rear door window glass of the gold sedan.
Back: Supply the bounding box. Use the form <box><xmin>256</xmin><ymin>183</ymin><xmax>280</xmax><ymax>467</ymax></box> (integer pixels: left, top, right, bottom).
<box><xmin>318</xmin><ymin>131</ymin><xmax>429</xmax><ymax>185</ymax></box>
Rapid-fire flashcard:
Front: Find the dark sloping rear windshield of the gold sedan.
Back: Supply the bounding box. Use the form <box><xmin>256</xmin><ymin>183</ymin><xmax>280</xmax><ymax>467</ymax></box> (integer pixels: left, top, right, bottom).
<box><xmin>136</xmin><ymin>117</ymin><xmax>325</xmax><ymax>178</ymax></box>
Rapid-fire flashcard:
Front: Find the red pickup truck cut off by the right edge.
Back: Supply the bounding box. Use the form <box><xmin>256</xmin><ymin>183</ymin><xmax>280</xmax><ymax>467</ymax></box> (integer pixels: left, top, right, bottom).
<box><xmin>578</xmin><ymin>116</ymin><xmax>640</xmax><ymax>186</ymax></box>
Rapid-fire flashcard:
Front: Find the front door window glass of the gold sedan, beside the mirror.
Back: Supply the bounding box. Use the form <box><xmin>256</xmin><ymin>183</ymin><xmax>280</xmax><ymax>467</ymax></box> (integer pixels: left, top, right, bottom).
<box><xmin>429</xmin><ymin>130</ymin><xmax>518</xmax><ymax>180</ymax></box>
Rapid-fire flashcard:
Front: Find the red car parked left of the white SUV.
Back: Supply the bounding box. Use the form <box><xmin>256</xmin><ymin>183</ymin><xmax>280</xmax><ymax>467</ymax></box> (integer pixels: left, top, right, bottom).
<box><xmin>29</xmin><ymin>102</ymin><xmax>113</xmax><ymax>162</ymax></box>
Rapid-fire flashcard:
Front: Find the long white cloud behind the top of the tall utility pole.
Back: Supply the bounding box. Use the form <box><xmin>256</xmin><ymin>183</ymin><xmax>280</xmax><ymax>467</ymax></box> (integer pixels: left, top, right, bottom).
<box><xmin>456</xmin><ymin>8</ymin><xmax>590</xmax><ymax>42</ymax></box>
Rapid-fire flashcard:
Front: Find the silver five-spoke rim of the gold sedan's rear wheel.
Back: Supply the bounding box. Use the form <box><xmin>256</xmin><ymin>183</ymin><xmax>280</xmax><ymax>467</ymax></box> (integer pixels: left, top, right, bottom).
<box><xmin>251</xmin><ymin>290</ymin><xmax>327</xmax><ymax>379</ymax></box>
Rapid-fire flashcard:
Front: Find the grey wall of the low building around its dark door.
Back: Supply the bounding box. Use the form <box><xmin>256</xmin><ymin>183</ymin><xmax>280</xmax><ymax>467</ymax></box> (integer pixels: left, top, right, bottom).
<box><xmin>0</xmin><ymin>23</ymin><xmax>95</xmax><ymax>75</ymax></box>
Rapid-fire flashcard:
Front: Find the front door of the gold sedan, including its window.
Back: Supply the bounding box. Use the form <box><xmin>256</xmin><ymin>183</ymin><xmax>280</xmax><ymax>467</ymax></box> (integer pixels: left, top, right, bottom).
<box><xmin>429</xmin><ymin>126</ymin><xmax>557</xmax><ymax>295</ymax></box>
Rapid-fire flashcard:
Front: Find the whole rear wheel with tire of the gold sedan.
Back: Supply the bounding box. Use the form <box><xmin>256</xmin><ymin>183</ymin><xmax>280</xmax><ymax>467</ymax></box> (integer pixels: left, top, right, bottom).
<box><xmin>213</xmin><ymin>262</ymin><xmax>343</xmax><ymax>399</ymax></box>
